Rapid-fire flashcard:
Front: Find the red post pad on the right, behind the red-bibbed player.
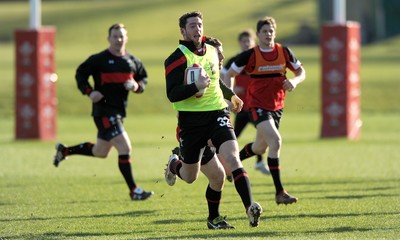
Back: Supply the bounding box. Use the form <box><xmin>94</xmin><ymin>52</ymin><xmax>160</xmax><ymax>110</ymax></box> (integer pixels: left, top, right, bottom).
<box><xmin>321</xmin><ymin>22</ymin><xmax>361</xmax><ymax>139</ymax></box>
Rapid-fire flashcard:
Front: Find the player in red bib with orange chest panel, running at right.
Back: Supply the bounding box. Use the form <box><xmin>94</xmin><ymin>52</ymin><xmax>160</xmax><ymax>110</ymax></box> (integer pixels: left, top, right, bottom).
<box><xmin>224</xmin><ymin>17</ymin><xmax>306</xmax><ymax>204</ymax></box>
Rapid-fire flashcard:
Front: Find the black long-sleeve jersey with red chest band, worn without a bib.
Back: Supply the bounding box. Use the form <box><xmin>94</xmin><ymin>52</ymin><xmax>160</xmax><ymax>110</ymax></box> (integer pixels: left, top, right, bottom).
<box><xmin>75</xmin><ymin>49</ymin><xmax>147</xmax><ymax>117</ymax></box>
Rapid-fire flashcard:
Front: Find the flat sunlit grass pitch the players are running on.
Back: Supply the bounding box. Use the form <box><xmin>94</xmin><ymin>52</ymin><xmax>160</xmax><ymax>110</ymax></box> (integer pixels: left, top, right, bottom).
<box><xmin>0</xmin><ymin>113</ymin><xmax>400</xmax><ymax>239</ymax></box>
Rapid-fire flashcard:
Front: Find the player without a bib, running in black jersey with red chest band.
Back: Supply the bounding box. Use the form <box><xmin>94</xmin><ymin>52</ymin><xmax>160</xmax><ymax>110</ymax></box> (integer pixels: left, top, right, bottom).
<box><xmin>53</xmin><ymin>23</ymin><xmax>153</xmax><ymax>200</ymax></box>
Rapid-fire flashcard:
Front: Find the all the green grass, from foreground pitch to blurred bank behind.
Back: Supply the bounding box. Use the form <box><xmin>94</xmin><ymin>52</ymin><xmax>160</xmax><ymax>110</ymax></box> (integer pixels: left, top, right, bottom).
<box><xmin>0</xmin><ymin>0</ymin><xmax>400</xmax><ymax>239</ymax></box>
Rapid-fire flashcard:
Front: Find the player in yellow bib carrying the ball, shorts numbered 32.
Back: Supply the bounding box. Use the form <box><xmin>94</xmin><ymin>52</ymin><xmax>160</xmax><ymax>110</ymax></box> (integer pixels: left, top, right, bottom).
<box><xmin>164</xmin><ymin>11</ymin><xmax>262</xmax><ymax>229</ymax></box>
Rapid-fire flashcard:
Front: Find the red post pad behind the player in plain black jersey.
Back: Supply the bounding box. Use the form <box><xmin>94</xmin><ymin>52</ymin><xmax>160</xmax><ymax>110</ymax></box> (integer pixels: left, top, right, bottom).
<box><xmin>15</xmin><ymin>27</ymin><xmax>57</xmax><ymax>140</ymax></box>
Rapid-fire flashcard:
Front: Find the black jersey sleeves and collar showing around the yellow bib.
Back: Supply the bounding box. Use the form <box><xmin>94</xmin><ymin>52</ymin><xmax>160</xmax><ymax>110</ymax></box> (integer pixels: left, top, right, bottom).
<box><xmin>164</xmin><ymin>36</ymin><xmax>235</xmax><ymax>102</ymax></box>
